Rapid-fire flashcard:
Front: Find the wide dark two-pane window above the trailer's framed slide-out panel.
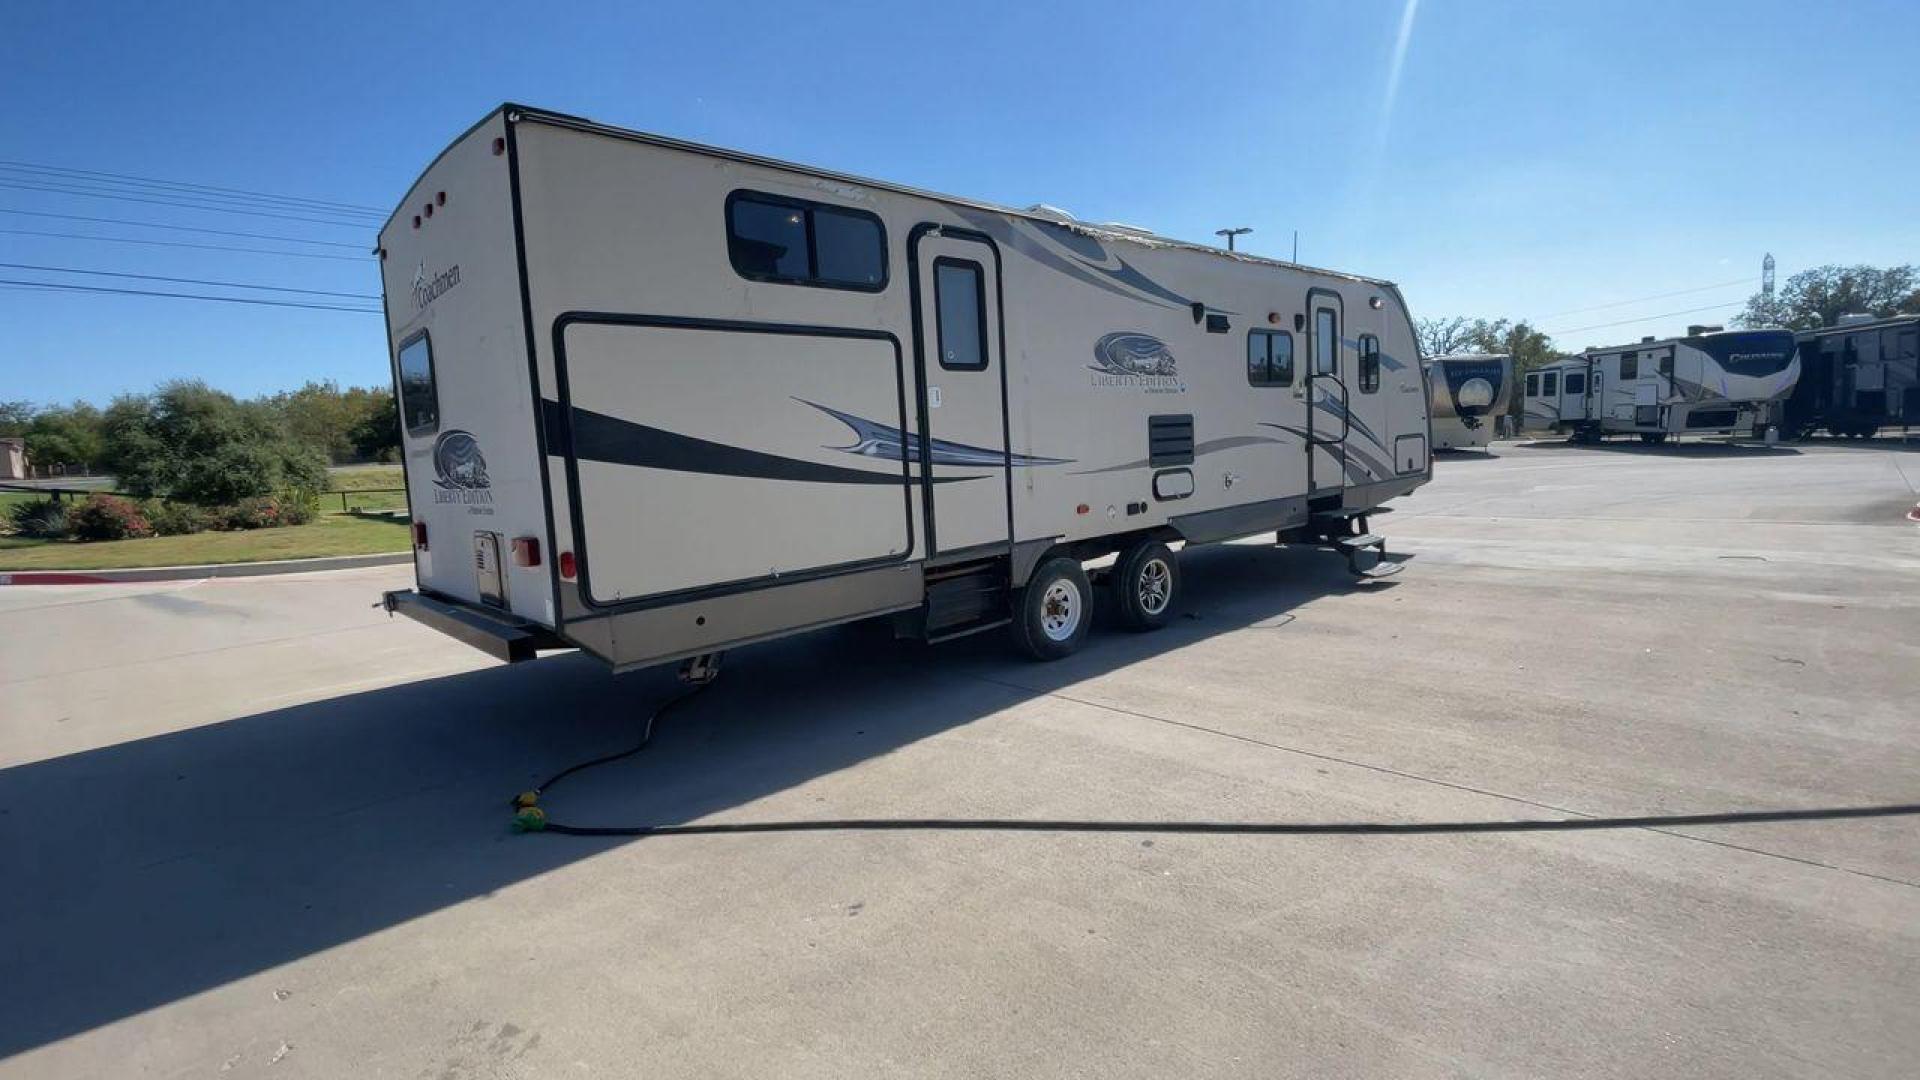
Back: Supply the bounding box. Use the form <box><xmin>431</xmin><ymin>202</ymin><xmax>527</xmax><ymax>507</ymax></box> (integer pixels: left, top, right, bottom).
<box><xmin>726</xmin><ymin>192</ymin><xmax>887</xmax><ymax>292</ymax></box>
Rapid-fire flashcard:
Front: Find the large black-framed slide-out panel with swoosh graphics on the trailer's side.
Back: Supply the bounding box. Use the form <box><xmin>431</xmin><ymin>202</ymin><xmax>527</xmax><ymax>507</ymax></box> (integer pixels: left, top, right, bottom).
<box><xmin>559</xmin><ymin>315</ymin><xmax>912</xmax><ymax>605</ymax></box>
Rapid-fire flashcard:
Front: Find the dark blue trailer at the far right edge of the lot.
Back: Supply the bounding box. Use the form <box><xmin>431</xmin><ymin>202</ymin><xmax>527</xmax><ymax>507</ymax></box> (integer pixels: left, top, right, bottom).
<box><xmin>1782</xmin><ymin>315</ymin><xmax>1920</xmax><ymax>438</ymax></box>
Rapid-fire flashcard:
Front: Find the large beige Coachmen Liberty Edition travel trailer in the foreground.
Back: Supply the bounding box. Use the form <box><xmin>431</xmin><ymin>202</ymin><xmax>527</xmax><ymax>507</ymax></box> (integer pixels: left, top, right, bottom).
<box><xmin>378</xmin><ymin>106</ymin><xmax>1430</xmax><ymax>669</ymax></box>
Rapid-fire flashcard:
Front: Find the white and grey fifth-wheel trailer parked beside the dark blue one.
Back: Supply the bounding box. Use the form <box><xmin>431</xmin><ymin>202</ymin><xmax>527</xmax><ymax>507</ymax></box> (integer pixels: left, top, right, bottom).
<box><xmin>1523</xmin><ymin>327</ymin><xmax>1801</xmax><ymax>444</ymax></box>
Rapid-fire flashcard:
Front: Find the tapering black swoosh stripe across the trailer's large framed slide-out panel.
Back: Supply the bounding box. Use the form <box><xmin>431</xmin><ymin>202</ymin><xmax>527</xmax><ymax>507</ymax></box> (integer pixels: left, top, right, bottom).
<box><xmin>568</xmin><ymin>407</ymin><xmax>981</xmax><ymax>484</ymax></box>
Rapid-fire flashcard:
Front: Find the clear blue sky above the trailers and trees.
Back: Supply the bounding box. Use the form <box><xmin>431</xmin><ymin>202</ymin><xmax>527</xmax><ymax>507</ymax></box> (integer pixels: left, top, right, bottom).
<box><xmin>0</xmin><ymin>0</ymin><xmax>1920</xmax><ymax>402</ymax></box>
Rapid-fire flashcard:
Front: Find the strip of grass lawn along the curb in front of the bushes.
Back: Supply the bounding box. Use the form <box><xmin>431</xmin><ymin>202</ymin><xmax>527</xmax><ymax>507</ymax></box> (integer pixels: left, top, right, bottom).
<box><xmin>0</xmin><ymin>511</ymin><xmax>413</xmax><ymax>571</ymax></box>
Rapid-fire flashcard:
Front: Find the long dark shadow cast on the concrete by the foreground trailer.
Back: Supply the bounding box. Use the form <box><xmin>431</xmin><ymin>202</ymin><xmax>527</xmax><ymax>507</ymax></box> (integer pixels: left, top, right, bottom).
<box><xmin>0</xmin><ymin>544</ymin><xmax>1394</xmax><ymax>1059</ymax></box>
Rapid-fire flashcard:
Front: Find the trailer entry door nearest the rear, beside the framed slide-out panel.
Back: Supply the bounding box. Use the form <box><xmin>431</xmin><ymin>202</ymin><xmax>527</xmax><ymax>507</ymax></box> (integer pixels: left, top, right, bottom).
<box><xmin>914</xmin><ymin>231</ymin><xmax>1012</xmax><ymax>555</ymax></box>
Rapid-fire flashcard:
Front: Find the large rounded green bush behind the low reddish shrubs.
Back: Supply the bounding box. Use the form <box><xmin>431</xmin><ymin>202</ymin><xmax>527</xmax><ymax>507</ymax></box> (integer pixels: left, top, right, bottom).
<box><xmin>102</xmin><ymin>380</ymin><xmax>326</xmax><ymax>505</ymax></box>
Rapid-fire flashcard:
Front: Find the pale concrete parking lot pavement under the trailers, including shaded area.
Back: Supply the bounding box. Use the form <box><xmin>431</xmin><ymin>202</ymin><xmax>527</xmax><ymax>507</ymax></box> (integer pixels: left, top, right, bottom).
<box><xmin>0</xmin><ymin>444</ymin><xmax>1920</xmax><ymax>1080</ymax></box>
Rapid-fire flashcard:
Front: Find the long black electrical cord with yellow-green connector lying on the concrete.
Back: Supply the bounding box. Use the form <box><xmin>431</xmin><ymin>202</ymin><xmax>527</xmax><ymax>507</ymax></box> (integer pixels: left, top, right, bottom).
<box><xmin>511</xmin><ymin>676</ymin><xmax>1920</xmax><ymax>836</ymax></box>
